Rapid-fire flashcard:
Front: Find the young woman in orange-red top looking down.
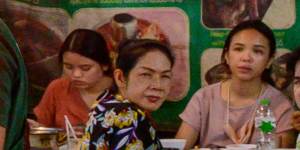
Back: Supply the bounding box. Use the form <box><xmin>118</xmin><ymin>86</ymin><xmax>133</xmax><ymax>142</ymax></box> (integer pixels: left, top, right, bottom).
<box><xmin>31</xmin><ymin>29</ymin><xmax>113</xmax><ymax>128</ymax></box>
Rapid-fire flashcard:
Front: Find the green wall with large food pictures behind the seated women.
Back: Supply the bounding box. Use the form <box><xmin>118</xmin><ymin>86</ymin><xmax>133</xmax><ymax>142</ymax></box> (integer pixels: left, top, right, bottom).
<box><xmin>0</xmin><ymin>0</ymin><xmax>300</xmax><ymax>131</ymax></box>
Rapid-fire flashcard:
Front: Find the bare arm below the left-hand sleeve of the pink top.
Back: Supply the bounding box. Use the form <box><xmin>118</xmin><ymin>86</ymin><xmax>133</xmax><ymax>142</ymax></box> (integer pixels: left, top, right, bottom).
<box><xmin>175</xmin><ymin>121</ymin><xmax>199</xmax><ymax>150</ymax></box>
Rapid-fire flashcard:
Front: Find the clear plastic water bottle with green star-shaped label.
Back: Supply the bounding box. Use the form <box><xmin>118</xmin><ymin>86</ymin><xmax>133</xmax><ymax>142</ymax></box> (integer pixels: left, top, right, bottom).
<box><xmin>255</xmin><ymin>99</ymin><xmax>276</xmax><ymax>150</ymax></box>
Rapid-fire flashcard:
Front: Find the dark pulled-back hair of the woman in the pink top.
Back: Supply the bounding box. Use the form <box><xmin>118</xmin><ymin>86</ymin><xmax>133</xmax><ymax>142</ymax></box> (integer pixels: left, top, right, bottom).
<box><xmin>221</xmin><ymin>20</ymin><xmax>276</xmax><ymax>84</ymax></box>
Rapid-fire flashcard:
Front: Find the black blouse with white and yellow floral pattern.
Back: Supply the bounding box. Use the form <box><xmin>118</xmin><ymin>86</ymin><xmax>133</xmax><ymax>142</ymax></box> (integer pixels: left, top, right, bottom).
<box><xmin>80</xmin><ymin>90</ymin><xmax>162</xmax><ymax>150</ymax></box>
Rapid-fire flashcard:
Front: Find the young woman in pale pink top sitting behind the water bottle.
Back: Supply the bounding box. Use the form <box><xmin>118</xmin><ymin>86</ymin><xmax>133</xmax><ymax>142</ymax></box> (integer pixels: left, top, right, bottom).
<box><xmin>176</xmin><ymin>20</ymin><xmax>294</xmax><ymax>149</ymax></box>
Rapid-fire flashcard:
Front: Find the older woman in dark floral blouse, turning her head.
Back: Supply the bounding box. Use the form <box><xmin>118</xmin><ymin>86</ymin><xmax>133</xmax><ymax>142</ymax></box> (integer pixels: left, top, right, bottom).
<box><xmin>80</xmin><ymin>39</ymin><xmax>174</xmax><ymax>150</ymax></box>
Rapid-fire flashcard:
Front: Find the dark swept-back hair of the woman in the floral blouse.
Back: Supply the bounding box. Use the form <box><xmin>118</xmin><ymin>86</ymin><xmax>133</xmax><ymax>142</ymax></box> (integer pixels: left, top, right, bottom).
<box><xmin>116</xmin><ymin>39</ymin><xmax>175</xmax><ymax>77</ymax></box>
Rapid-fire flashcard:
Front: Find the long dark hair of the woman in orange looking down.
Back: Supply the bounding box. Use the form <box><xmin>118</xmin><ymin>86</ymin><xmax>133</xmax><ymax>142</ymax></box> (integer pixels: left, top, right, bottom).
<box><xmin>59</xmin><ymin>29</ymin><xmax>113</xmax><ymax>76</ymax></box>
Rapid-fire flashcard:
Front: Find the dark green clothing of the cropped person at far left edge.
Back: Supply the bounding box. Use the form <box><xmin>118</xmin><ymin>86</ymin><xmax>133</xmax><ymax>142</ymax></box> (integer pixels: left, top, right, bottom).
<box><xmin>0</xmin><ymin>19</ymin><xmax>28</xmax><ymax>150</ymax></box>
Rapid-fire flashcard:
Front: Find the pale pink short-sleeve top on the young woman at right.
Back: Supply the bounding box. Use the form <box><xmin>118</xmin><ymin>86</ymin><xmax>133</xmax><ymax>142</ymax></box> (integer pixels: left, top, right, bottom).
<box><xmin>180</xmin><ymin>82</ymin><xmax>293</xmax><ymax>147</ymax></box>
